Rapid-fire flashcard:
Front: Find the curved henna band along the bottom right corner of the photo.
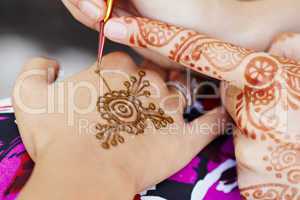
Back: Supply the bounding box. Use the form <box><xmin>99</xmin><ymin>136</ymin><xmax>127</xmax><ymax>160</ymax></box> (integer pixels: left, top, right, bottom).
<box><xmin>241</xmin><ymin>183</ymin><xmax>300</xmax><ymax>200</ymax></box>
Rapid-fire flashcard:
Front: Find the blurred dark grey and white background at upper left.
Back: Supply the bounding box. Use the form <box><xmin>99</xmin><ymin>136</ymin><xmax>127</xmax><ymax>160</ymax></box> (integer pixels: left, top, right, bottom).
<box><xmin>0</xmin><ymin>0</ymin><xmax>136</xmax><ymax>99</ymax></box>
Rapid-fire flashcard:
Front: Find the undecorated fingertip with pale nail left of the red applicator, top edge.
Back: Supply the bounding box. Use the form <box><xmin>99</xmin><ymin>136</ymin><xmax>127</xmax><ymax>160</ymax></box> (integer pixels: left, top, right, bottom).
<box><xmin>62</xmin><ymin>0</ymin><xmax>107</xmax><ymax>30</ymax></box>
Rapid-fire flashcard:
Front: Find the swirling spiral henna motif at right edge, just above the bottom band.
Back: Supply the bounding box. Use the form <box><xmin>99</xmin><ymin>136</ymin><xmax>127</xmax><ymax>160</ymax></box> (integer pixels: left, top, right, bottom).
<box><xmin>263</xmin><ymin>144</ymin><xmax>300</xmax><ymax>185</ymax></box>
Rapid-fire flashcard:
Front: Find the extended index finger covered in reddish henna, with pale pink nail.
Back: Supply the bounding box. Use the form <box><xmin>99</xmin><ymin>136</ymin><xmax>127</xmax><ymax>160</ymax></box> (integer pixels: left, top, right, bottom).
<box><xmin>105</xmin><ymin>17</ymin><xmax>268</xmax><ymax>87</ymax></box>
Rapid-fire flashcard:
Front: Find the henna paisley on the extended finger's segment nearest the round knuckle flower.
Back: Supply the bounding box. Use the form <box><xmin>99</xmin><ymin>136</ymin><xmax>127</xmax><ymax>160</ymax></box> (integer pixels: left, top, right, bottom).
<box><xmin>169</xmin><ymin>37</ymin><xmax>250</xmax><ymax>72</ymax></box>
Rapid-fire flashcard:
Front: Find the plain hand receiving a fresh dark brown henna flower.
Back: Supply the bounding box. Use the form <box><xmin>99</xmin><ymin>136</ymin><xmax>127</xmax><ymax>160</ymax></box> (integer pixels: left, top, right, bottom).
<box><xmin>13</xmin><ymin>53</ymin><xmax>227</xmax><ymax>199</ymax></box>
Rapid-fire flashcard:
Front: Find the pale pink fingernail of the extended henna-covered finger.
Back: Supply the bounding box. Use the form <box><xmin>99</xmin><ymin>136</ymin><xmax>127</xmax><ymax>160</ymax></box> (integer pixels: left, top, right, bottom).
<box><xmin>105</xmin><ymin>20</ymin><xmax>127</xmax><ymax>40</ymax></box>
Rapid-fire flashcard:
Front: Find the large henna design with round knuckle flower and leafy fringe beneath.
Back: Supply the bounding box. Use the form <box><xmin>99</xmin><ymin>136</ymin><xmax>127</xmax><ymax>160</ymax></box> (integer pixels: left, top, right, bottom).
<box><xmin>236</xmin><ymin>55</ymin><xmax>300</xmax><ymax>143</ymax></box>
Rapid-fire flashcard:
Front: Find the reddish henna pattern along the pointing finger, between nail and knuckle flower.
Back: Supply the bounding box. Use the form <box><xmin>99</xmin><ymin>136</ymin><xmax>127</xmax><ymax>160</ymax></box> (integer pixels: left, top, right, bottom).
<box><xmin>124</xmin><ymin>17</ymin><xmax>252</xmax><ymax>79</ymax></box>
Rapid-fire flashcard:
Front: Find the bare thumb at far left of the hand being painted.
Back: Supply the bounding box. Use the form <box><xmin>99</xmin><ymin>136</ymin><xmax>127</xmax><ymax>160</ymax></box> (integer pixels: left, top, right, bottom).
<box><xmin>12</xmin><ymin>58</ymin><xmax>59</xmax><ymax>159</ymax></box>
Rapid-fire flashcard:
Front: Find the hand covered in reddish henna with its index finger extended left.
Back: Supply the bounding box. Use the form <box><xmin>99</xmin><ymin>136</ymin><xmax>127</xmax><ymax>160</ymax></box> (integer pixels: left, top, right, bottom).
<box><xmin>106</xmin><ymin>17</ymin><xmax>300</xmax><ymax>199</ymax></box>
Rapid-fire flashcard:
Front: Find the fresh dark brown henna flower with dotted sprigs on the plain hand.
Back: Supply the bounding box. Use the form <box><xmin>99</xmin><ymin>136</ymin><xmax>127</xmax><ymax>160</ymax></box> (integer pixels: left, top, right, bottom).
<box><xmin>96</xmin><ymin>71</ymin><xmax>174</xmax><ymax>149</ymax></box>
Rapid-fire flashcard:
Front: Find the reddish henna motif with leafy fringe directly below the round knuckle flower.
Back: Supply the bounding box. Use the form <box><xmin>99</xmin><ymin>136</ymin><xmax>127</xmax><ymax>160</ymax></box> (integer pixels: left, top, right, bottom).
<box><xmin>235</xmin><ymin>83</ymin><xmax>281</xmax><ymax>140</ymax></box>
